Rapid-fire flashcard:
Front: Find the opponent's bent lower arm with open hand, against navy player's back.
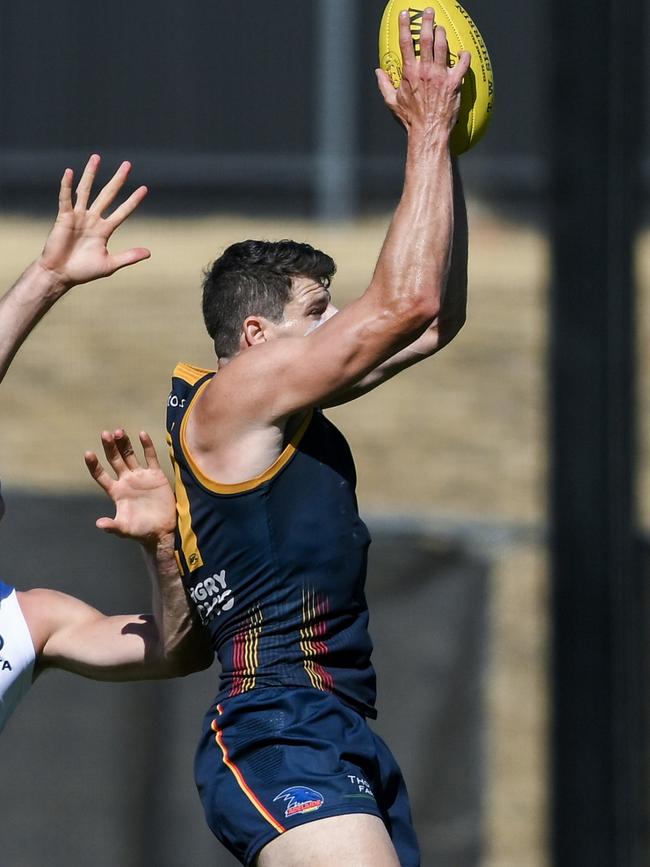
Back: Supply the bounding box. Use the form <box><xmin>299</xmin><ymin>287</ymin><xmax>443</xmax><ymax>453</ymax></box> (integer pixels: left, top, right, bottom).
<box><xmin>33</xmin><ymin>430</ymin><xmax>213</xmax><ymax>680</ymax></box>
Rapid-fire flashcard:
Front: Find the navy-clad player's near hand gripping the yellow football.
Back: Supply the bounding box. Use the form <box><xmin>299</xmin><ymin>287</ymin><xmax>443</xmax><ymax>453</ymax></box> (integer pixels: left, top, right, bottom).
<box><xmin>376</xmin><ymin>8</ymin><xmax>471</xmax><ymax>139</ymax></box>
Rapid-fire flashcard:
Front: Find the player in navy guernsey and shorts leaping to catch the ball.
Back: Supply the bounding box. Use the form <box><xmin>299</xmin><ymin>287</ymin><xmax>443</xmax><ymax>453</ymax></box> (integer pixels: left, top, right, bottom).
<box><xmin>168</xmin><ymin>9</ymin><xmax>470</xmax><ymax>867</ymax></box>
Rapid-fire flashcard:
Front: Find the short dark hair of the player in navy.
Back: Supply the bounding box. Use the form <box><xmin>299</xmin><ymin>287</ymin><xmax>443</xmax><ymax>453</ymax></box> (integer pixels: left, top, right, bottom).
<box><xmin>203</xmin><ymin>241</ymin><xmax>336</xmax><ymax>358</ymax></box>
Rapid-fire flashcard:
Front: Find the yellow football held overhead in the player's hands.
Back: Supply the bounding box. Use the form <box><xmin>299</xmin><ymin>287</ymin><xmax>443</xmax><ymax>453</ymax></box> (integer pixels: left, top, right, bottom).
<box><xmin>379</xmin><ymin>0</ymin><xmax>494</xmax><ymax>154</ymax></box>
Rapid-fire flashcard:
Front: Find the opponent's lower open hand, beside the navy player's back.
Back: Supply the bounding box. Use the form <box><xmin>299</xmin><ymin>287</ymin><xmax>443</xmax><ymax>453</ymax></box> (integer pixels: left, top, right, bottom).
<box><xmin>84</xmin><ymin>428</ymin><xmax>176</xmax><ymax>544</ymax></box>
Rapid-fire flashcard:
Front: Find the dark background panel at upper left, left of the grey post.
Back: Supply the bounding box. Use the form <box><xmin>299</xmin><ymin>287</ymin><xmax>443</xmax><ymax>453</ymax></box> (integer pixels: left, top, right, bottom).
<box><xmin>0</xmin><ymin>0</ymin><xmax>314</xmax><ymax>155</ymax></box>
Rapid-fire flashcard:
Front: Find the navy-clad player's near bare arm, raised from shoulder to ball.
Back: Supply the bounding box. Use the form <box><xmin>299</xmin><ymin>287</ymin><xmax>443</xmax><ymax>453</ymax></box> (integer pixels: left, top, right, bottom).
<box><xmin>194</xmin><ymin>10</ymin><xmax>469</xmax><ymax>428</ymax></box>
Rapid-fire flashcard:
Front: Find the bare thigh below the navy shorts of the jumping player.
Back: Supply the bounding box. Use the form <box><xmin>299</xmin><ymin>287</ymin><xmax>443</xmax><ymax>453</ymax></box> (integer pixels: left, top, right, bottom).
<box><xmin>256</xmin><ymin>813</ymin><xmax>400</xmax><ymax>867</ymax></box>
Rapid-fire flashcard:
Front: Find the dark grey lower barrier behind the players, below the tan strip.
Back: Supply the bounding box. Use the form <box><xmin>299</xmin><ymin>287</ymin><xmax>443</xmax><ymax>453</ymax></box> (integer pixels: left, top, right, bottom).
<box><xmin>0</xmin><ymin>492</ymin><xmax>487</xmax><ymax>867</ymax></box>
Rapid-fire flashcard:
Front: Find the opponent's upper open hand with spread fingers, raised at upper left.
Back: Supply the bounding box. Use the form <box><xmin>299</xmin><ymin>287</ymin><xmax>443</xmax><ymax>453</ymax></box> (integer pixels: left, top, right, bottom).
<box><xmin>38</xmin><ymin>154</ymin><xmax>151</xmax><ymax>287</ymax></box>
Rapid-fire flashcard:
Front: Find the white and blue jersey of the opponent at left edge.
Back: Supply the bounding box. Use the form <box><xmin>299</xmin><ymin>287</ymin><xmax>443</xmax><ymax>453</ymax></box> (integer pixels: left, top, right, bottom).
<box><xmin>0</xmin><ymin>581</ymin><xmax>36</xmax><ymax>731</ymax></box>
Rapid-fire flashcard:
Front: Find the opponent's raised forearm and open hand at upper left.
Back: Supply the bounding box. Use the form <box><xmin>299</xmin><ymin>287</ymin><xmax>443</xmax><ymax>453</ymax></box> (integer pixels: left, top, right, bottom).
<box><xmin>0</xmin><ymin>154</ymin><xmax>150</xmax><ymax>382</ymax></box>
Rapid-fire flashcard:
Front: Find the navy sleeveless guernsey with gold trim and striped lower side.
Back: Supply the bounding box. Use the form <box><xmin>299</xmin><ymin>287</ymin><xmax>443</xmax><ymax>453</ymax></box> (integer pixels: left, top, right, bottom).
<box><xmin>167</xmin><ymin>364</ymin><xmax>376</xmax><ymax>718</ymax></box>
